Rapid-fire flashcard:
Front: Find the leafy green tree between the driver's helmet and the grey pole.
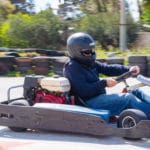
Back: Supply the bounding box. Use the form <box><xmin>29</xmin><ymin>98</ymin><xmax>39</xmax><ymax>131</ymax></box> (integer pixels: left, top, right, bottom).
<box><xmin>78</xmin><ymin>13</ymin><xmax>119</xmax><ymax>49</ymax></box>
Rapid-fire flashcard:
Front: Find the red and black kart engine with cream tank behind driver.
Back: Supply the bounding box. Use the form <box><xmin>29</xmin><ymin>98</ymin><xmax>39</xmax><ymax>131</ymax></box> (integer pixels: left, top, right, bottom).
<box><xmin>23</xmin><ymin>76</ymin><xmax>74</xmax><ymax>105</ymax></box>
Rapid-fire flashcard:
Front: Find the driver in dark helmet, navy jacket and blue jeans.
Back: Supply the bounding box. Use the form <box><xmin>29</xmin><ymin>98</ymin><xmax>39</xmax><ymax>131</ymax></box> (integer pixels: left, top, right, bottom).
<box><xmin>64</xmin><ymin>33</ymin><xmax>150</xmax><ymax>119</ymax></box>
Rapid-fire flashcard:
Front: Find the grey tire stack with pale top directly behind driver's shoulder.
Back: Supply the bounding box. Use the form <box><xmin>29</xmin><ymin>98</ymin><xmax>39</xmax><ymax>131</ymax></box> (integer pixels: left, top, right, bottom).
<box><xmin>52</xmin><ymin>57</ymin><xmax>69</xmax><ymax>76</ymax></box>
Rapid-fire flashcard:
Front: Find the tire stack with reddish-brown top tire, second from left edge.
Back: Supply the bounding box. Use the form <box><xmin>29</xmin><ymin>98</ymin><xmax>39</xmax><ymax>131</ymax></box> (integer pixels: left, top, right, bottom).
<box><xmin>15</xmin><ymin>57</ymin><xmax>32</xmax><ymax>73</ymax></box>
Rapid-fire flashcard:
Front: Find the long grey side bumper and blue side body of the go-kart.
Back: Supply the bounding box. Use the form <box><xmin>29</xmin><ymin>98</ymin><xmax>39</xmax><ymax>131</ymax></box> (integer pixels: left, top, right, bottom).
<box><xmin>0</xmin><ymin>72</ymin><xmax>150</xmax><ymax>139</ymax></box>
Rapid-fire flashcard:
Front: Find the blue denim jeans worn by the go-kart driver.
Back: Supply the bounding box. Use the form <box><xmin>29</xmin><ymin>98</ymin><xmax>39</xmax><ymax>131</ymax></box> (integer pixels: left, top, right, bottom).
<box><xmin>86</xmin><ymin>89</ymin><xmax>150</xmax><ymax>119</ymax></box>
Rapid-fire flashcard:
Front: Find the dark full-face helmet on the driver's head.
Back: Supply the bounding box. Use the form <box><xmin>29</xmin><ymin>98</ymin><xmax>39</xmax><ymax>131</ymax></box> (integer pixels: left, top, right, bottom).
<box><xmin>67</xmin><ymin>32</ymin><xmax>96</xmax><ymax>65</ymax></box>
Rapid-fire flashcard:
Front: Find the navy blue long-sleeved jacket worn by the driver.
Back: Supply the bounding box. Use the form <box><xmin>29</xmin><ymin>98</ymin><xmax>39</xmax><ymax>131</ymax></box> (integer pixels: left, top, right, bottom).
<box><xmin>64</xmin><ymin>59</ymin><xmax>129</xmax><ymax>100</ymax></box>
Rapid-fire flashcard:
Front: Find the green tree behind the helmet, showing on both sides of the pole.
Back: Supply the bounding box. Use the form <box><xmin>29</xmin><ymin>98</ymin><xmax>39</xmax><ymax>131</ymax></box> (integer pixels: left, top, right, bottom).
<box><xmin>75</xmin><ymin>12</ymin><xmax>137</xmax><ymax>50</ymax></box>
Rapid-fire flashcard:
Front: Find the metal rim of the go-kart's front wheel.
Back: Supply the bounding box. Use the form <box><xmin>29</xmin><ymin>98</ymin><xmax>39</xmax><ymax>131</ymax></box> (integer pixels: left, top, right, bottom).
<box><xmin>122</xmin><ymin>116</ymin><xmax>136</xmax><ymax>128</ymax></box>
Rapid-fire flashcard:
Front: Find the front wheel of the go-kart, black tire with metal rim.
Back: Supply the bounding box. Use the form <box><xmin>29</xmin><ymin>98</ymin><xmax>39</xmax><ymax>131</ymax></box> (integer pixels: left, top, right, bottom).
<box><xmin>117</xmin><ymin>109</ymin><xmax>148</xmax><ymax>140</ymax></box>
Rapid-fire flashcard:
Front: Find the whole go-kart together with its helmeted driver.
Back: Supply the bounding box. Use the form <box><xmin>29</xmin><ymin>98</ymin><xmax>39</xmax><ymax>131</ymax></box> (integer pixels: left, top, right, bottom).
<box><xmin>0</xmin><ymin>33</ymin><xmax>150</xmax><ymax>139</ymax></box>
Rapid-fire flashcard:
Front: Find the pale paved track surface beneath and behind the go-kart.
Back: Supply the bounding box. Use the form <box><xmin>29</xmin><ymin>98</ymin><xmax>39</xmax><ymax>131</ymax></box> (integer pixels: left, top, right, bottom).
<box><xmin>0</xmin><ymin>77</ymin><xmax>150</xmax><ymax>150</ymax></box>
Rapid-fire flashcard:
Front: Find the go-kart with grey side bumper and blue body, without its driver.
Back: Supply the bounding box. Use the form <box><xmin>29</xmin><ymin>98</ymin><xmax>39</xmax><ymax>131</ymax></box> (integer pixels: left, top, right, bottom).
<box><xmin>0</xmin><ymin>71</ymin><xmax>150</xmax><ymax>139</ymax></box>
